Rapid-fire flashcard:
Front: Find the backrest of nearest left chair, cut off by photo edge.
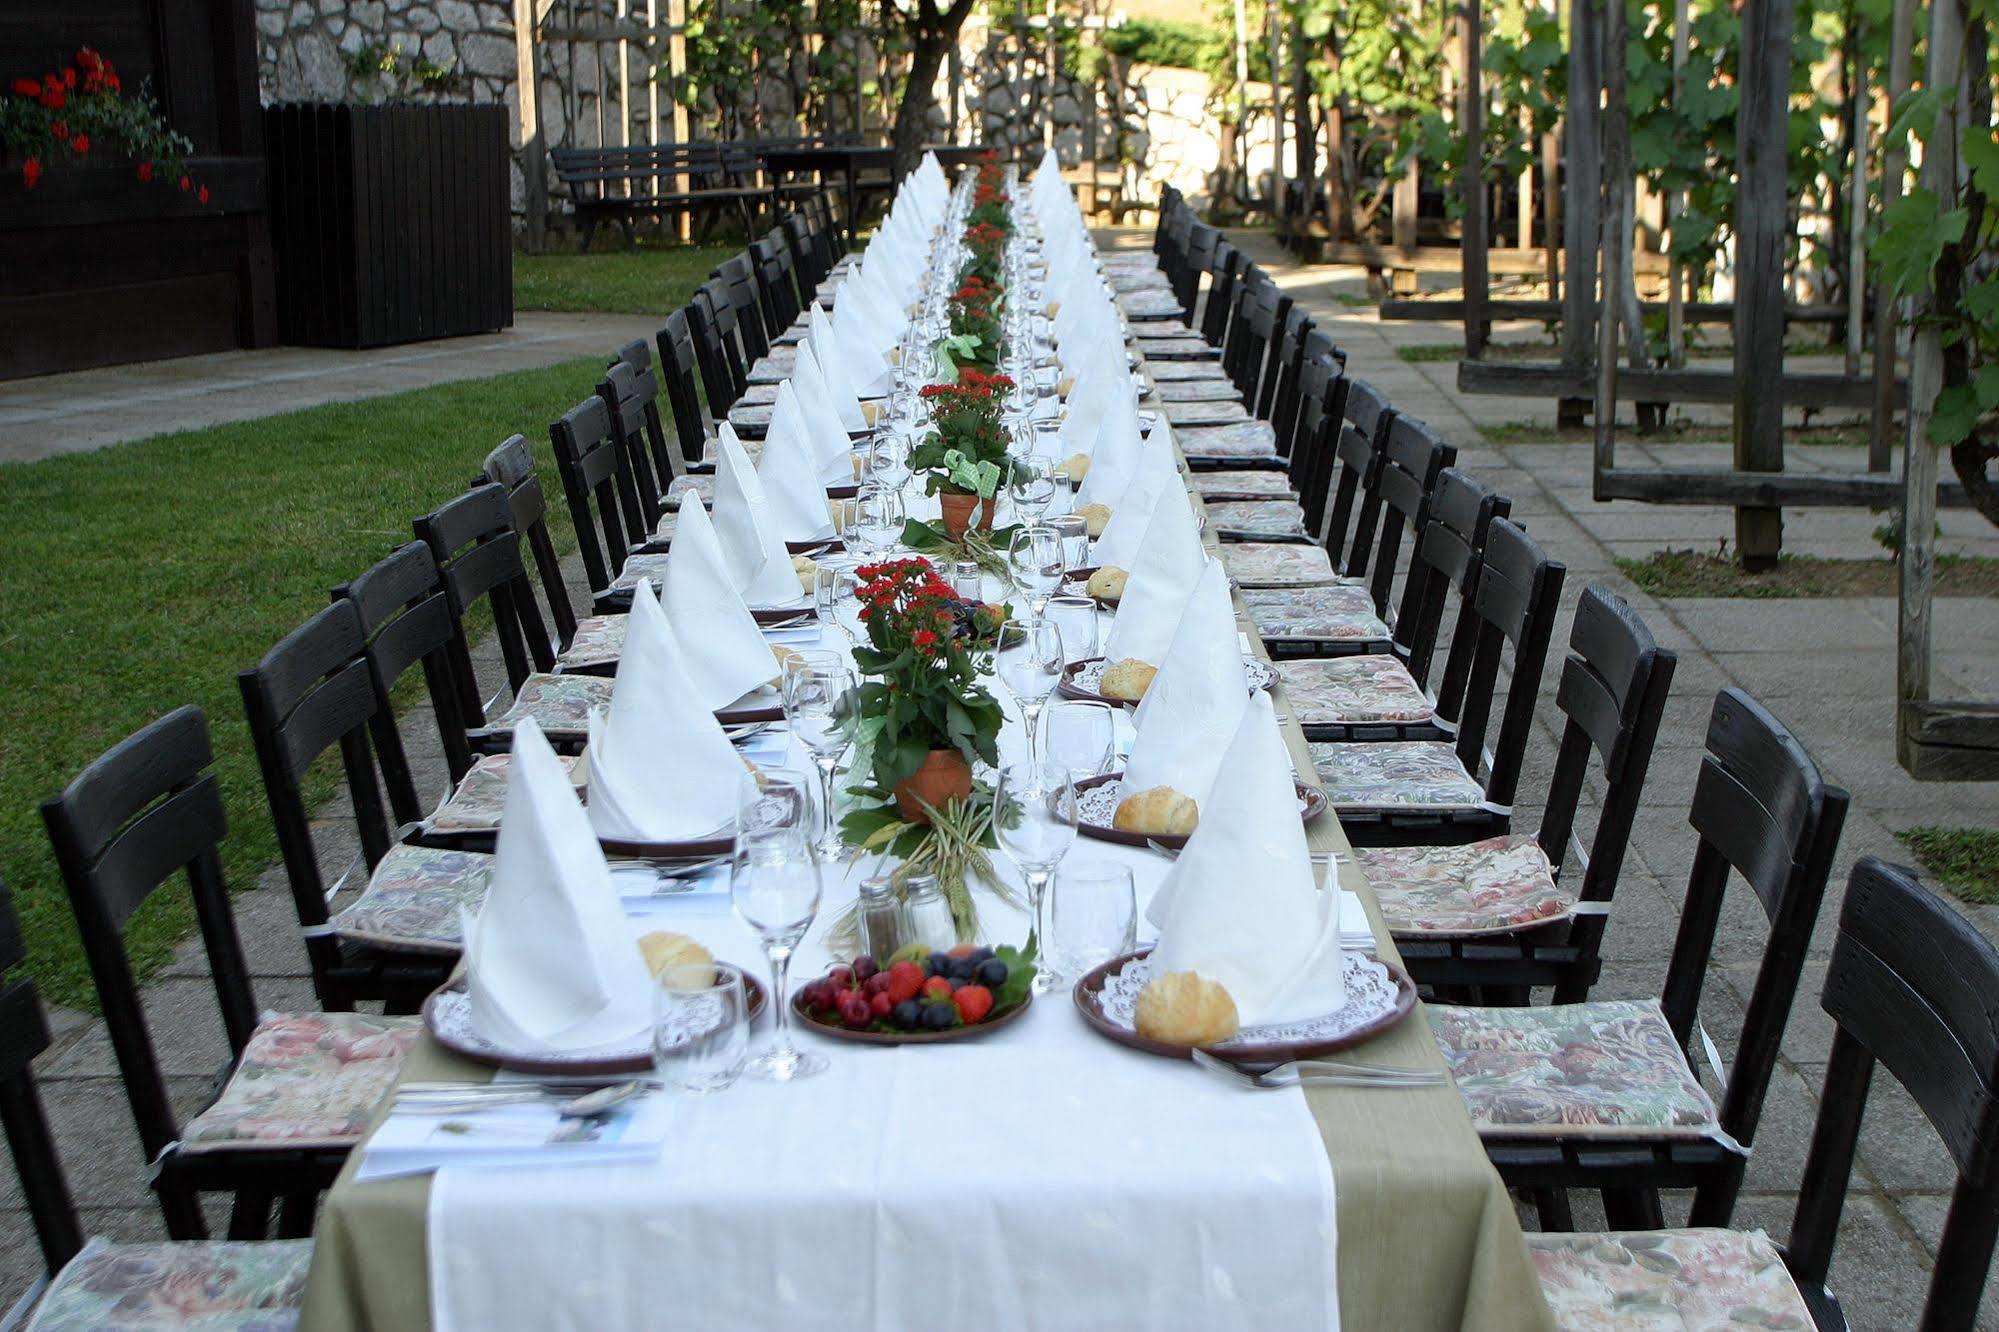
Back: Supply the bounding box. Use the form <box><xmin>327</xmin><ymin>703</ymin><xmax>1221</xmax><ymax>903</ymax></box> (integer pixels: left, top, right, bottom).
<box><xmin>0</xmin><ymin>884</ymin><xmax>84</xmax><ymax>1280</ymax></box>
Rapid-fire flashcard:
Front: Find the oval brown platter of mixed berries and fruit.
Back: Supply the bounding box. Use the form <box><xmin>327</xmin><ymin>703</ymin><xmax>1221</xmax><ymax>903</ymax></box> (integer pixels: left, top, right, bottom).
<box><xmin>792</xmin><ymin>944</ymin><xmax>1035</xmax><ymax>1046</ymax></box>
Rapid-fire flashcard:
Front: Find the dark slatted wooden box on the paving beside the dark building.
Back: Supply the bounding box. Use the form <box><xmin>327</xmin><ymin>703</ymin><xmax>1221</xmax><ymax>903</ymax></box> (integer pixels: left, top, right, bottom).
<box><xmin>264</xmin><ymin>104</ymin><xmax>514</xmax><ymax>346</ymax></box>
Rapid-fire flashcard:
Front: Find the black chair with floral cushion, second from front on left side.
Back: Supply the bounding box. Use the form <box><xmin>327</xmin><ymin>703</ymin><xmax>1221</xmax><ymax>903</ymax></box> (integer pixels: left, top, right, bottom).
<box><xmin>42</xmin><ymin>704</ymin><xmax>419</xmax><ymax>1240</ymax></box>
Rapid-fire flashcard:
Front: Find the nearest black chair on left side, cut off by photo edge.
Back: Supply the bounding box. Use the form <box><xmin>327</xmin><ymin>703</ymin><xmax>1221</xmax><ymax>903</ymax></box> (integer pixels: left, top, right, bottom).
<box><xmin>0</xmin><ymin>872</ymin><xmax>312</xmax><ymax>1328</ymax></box>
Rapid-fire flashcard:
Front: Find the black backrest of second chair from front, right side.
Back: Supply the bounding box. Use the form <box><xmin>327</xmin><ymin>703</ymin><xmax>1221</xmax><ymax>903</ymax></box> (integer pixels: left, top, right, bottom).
<box><xmin>1663</xmin><ymin>688</ymin><xmax>1847</xmax><ymax>1226</ymax></box>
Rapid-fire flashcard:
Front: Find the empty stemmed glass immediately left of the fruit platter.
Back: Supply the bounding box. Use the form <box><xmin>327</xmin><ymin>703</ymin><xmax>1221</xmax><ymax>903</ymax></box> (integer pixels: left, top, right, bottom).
<box><xmin>730</xmin><ymin>768</ymin><xmax>826</xmax><ymax>1082</ymax></box>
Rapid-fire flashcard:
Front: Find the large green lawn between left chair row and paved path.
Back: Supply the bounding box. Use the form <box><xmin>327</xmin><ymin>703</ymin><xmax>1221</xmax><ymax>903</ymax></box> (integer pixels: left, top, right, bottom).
<box><xmin>0</xmin><ymin>356</ymin><xmax>615</xmax><ymax>1008</ymax></box>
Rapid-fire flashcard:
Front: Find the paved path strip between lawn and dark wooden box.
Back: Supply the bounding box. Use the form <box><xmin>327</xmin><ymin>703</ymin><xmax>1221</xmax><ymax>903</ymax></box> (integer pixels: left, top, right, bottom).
<box><xmin>0</xmin><ymin>310</ymin><xmax>660</xmax><ymax>462</ymax></box>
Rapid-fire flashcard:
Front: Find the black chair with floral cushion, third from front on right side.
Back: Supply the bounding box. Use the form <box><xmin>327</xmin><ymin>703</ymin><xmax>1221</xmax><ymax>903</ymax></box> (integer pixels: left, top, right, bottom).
<box><xmin>1353</xmin><ymin>588</ymin><xmax>1677</xmax><ymax>1004</ymax></box>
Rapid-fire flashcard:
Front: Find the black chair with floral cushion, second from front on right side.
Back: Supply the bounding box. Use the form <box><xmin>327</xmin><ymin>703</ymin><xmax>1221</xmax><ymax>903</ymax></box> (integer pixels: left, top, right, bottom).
<box><xmin>1429</xmin><ymin>684</ymin><xmax>1847</xmax><ymax>1230</ymax></box>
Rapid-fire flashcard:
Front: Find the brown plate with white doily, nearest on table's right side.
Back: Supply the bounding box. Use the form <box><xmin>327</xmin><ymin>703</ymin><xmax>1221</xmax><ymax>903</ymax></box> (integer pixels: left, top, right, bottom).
<box><xmin>1071</xmin><ymin>948</ymin><xmax>1415</xmax><ymax>1068</ymax></box>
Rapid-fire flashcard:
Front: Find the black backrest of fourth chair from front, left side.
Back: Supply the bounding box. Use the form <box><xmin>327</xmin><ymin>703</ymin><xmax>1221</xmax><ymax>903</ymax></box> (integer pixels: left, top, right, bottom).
<box><xmin>334</xmin><ymin>536</ymin><xmax>475</xmax><ymax>824</ymax></box>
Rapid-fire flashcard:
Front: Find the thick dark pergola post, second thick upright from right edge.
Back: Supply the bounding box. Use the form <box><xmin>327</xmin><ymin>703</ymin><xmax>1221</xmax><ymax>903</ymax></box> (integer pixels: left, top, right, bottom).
<box><xmin>1735</xmin><ymin>0</ymin><xmax>1793</xmax><ymax>572</ymax></box>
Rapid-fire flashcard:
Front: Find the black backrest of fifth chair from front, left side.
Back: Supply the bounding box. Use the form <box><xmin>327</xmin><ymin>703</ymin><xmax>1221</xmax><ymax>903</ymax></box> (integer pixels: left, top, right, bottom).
<box><xmin>412</xmin><ymin>482</ymin><xmax>555</xmax><ymax>730</ymax></box>
